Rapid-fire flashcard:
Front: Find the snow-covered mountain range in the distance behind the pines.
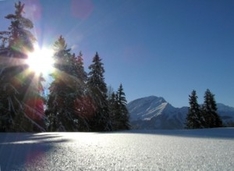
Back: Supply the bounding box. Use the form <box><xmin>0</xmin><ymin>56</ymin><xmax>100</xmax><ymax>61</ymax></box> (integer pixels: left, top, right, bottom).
<box><xmin>127</xmin><ymin>96</ymin><xmax>234</xmax><ymax>129</ymax></box>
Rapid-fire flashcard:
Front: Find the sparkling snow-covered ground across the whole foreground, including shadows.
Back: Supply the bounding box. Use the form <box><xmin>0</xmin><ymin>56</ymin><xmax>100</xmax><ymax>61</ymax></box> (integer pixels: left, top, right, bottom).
<box><xmin>0</xmin><ymin>128</ymin><xmax>234</xmax><ymax>171</ymax></box>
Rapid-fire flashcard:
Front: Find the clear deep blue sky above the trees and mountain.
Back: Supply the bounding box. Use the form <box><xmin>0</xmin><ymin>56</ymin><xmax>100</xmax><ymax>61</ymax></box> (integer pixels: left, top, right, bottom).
<box><xmin>0</xmin><ymin>0</ymin><xmax>234</xmax><ymax>107</ymax></box>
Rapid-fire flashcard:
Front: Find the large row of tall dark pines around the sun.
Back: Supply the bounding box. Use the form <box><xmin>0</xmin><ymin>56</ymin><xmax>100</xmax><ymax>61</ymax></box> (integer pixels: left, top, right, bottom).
<box><xmin>0</xmin><ymin>1</ymin><xmax>130</xmax><ymax>132</ymax></box>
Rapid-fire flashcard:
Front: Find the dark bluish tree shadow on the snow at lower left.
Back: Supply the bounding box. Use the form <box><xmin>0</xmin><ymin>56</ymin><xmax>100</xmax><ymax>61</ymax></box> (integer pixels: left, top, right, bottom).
<box><xmin>0</xmin><ymin>133</ymin><xmax>68</xmax><ymax>171</ymax></box>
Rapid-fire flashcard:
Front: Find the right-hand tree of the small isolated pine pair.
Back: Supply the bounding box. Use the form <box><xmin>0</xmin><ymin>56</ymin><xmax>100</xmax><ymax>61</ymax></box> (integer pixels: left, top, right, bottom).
<box><xmin>202</xmin><ymin>89</ymin><xmax>222</xmax><ymax>128</ymax></box>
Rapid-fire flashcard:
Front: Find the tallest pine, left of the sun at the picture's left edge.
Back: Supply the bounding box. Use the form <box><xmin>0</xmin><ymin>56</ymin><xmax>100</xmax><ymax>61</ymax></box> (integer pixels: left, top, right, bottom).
<box><xmin>0</xmin><ymin>2</ymin><xmax>44</xmax><ymax>131</ymax></box>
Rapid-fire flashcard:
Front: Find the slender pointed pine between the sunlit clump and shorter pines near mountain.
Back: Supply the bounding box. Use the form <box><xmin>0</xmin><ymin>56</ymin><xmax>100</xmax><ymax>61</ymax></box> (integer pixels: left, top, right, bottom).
<box><xmin>87</xmin><ymin>53</ymin><xmax>112</xmax><ymax>131</ymax></box>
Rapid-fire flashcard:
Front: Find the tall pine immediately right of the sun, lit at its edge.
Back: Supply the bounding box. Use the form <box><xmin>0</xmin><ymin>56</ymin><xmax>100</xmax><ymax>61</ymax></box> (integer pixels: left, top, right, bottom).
<box><xmin>46</xmin><ymin>36</ymin><xmax>80</xmax><ymax>131</ymax></box>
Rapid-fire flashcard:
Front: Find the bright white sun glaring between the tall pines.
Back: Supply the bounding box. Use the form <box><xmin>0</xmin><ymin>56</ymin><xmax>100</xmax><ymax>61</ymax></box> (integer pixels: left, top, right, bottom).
<box><xmin>26</xmin><ymin>46</ymin><xmax>54</xmax><ymax>75</ymax></box>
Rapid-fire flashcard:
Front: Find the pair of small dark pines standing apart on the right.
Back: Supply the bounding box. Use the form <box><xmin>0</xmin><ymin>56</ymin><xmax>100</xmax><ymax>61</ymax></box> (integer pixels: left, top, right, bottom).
<box><xmin>185</xmin><ymin>89</ymin><xmax>223</xmax><ymax>129</ymax></box>
